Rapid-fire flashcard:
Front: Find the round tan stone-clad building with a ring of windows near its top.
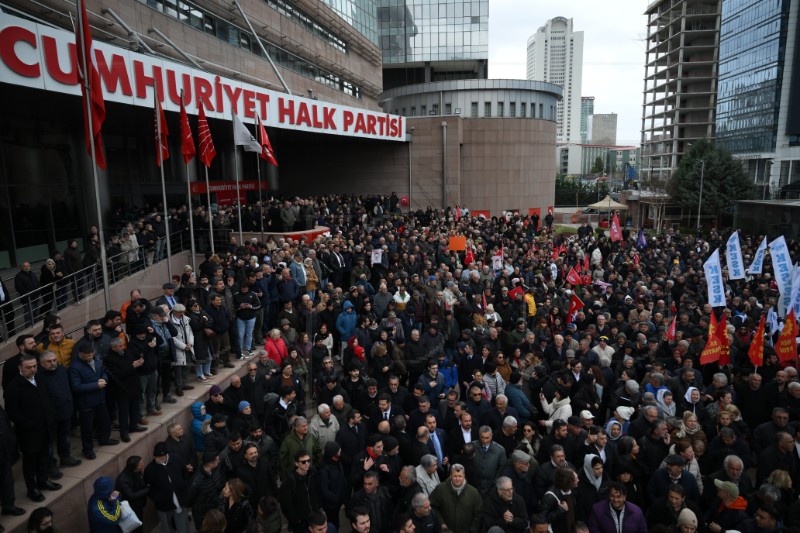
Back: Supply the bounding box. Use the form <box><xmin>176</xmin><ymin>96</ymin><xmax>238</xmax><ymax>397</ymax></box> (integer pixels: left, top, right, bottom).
<box><xmin>380</xmin><ymin>80</ymin><xmax>561</xmax><ymax>214</ymax></box>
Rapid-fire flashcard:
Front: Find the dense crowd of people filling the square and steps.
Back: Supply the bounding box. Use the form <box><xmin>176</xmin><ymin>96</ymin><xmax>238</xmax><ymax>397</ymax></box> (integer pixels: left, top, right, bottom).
<box><xmin>0</xmin><ymin>196</ymin><xmax>800</xmax><ymax>533</ymax></box>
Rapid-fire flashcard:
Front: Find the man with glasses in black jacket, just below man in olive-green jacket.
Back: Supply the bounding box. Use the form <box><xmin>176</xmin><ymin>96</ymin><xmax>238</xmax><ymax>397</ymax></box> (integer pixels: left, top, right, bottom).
<box><xmin>278</xmin><ymin>450</ymin><xmax>322</xmax><ymax>533</ymax></box>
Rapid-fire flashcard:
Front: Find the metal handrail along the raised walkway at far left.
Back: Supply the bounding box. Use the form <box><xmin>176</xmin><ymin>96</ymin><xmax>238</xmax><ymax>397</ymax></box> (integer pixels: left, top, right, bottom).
<box><xmin>0</xmin><ymin>231</ymin><xmax>186</xmax><ymax>340</ymax></box>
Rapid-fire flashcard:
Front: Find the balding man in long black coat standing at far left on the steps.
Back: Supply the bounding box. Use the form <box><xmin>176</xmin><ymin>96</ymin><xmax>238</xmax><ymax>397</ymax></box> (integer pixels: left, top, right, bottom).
<box><xmin>5</xmin><ymin>355</ymin><xmax>61</xmax><ymax>502</ymax></box>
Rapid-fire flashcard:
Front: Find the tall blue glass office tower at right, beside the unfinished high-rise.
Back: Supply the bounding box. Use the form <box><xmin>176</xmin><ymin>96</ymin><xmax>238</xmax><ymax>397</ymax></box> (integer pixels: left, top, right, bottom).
<box><xmin>717</xmin><ymin>0</ymin><xmax>791</xmax><ymax>154</ymax></box>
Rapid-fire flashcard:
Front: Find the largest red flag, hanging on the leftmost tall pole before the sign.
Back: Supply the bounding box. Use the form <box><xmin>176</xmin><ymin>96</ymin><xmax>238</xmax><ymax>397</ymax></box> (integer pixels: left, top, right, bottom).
<box><xmin>75</xmin><ymin>0</ymin><xmax>106</xmax><ymax>168</ymax></box>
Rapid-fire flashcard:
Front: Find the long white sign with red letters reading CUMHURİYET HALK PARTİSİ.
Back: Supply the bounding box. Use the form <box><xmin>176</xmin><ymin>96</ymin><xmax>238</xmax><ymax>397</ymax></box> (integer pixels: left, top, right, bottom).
<box><xmin>0</xmin><ymin>13</ymin><xmax>406</xmax><ymax>142</ymax></box>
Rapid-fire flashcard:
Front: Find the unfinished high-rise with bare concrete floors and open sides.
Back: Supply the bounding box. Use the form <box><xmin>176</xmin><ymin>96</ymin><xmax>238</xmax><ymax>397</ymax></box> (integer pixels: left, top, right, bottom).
<box><xmin>641</xmin><ymin>0</ymin><xmax>722</xmax><ymax>180</ymax></box>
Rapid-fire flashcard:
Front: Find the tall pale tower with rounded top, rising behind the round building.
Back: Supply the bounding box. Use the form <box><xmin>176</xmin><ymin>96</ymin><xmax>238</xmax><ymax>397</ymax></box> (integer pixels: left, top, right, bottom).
<box><xmin>526</xmin><ymin>17</ymin><xmax>583</xmax><ymax>143</ymax></box>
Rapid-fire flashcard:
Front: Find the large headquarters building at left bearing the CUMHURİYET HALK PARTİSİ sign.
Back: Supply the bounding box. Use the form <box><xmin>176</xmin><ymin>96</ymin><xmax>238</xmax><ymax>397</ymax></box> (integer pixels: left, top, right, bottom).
<box><xmin>0</xmin><ymin>0</ymin><xmax>400</xmax><ymax>268</ymax></box>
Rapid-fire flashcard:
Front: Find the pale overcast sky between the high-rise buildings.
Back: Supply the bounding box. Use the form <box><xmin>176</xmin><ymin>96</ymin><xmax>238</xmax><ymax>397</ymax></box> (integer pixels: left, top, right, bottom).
<box><xmin>489</xmin><ymin>0</ymin><xmax>649</xmax><ymax>144</ymax></box>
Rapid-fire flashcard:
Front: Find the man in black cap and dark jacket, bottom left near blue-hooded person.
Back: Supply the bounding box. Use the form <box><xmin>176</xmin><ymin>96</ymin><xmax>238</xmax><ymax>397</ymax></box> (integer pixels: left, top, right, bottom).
<box><xmin>144</xmin><ymin>442</ymin><xmax>189</xmax><ymax>533</ymax></box>
